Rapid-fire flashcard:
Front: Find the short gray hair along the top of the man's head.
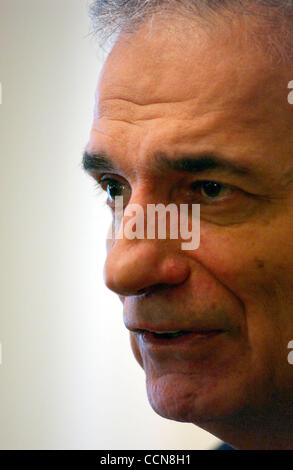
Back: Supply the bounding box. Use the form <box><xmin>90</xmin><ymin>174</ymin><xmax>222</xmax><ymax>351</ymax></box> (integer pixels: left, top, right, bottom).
<box><xmin>90</xmin><ymin>0</ymin><xmax>293</xmax><ymax>60</ymax></box>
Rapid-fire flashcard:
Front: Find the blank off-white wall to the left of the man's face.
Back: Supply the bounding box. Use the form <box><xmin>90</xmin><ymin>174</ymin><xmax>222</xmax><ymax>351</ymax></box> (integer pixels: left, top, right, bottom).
<box><xmin>0</xmin><ymin>0</ymin><xmax>218</xmax><ymax>449</ymax></box>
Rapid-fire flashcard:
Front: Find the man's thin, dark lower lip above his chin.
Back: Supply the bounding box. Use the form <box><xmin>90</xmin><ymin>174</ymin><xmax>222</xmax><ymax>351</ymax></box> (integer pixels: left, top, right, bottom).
<box><xmin>139</xmin><ymin>330</ymin><xmax>224</xmax><ymax>347</ymax></box>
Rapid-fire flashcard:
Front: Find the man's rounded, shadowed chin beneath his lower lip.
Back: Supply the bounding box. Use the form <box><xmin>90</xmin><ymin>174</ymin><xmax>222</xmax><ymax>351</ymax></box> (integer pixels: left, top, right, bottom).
<box><xmin>132</xmin><ymin>332</ymin><xmax>277</xmax><ymax>427</ymax></box>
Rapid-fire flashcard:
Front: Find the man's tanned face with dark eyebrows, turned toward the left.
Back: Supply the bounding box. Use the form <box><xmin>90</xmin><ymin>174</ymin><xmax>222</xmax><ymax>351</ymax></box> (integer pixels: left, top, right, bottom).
<box><xmin>87</xmin><ymin>15</ymin><xmax>293</xmax><ymax>423</ymax></box>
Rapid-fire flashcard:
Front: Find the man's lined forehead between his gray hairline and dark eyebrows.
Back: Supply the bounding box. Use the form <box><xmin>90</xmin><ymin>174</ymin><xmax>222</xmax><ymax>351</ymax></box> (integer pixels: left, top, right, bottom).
<box><xmin>90</xmin><ymin>15</ymin><xmax>293</xmax><ymax>178</ymax></box>
